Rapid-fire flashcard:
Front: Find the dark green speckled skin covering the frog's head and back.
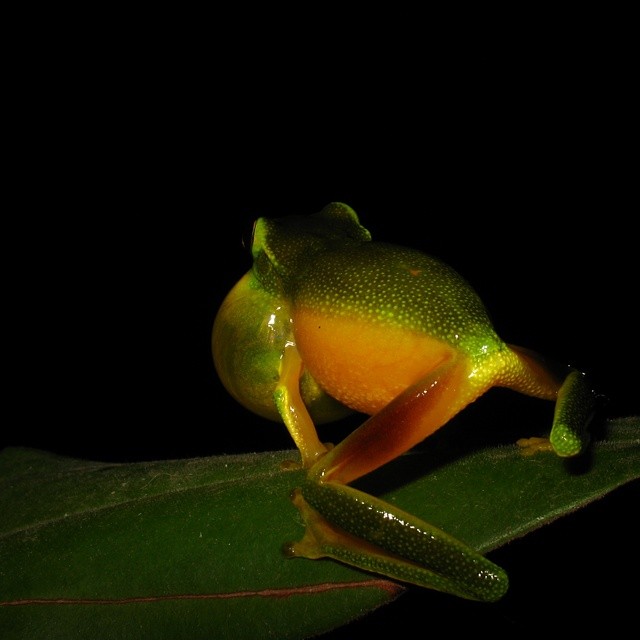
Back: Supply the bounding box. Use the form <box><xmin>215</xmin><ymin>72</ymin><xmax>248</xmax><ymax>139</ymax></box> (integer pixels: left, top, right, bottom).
<box><xmin>252</xmin><ymin>203</ymin><xmax>501</xmax><ymax>348</ymax></box>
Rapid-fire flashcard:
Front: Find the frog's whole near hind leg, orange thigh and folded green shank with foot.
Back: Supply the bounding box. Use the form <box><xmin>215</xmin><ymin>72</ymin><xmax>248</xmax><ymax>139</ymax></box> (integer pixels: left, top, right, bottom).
<box><xmin>285</xmin><ymin>359</ymin><xmax>508</xmax><ymax>601</ymax></box>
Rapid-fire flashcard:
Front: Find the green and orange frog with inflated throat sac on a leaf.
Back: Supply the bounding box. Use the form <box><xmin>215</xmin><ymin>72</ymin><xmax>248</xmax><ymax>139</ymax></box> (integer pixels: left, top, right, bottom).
<box><xmin>212</xmin><ymin>202</ymin><xmax>596</xmax><ymax>602</ymax></box>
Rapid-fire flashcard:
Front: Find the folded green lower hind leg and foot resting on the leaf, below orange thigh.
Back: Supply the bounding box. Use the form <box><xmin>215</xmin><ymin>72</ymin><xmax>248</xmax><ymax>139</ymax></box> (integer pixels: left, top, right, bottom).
<box><xmin>284</xmin><ymin>481</ymin><xmax>509</xmax><ymax>602</ymax></box>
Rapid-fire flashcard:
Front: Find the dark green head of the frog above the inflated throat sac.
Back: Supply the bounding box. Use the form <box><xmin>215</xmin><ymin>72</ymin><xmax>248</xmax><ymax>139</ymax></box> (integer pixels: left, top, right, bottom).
<box><xmin>251</xmin><ymin>202</ymin><xmax>371</xmax><ymax>288</ymax></box>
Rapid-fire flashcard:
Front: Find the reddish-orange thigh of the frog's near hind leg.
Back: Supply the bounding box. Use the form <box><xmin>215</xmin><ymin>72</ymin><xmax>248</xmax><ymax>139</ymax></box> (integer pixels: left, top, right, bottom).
<box><xmin>312</xmin><ymin>356</ymin><xmax>490</xmax><ymax>484</ymax></box>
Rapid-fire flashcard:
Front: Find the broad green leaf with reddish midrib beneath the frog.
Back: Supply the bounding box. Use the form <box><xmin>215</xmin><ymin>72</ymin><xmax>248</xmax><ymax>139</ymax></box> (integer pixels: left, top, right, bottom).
<box><xmin>0</xmin><ymin>417</ymin><xmax>640</xmax><ymax>640</ymax></box>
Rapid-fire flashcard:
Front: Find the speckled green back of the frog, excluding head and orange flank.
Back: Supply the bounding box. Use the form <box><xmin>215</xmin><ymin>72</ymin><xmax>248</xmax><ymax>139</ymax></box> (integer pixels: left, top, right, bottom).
<box><xmin>293</xmin><ymin>242</ymin><xmax>495</xmax><ymax>348</ymax></box>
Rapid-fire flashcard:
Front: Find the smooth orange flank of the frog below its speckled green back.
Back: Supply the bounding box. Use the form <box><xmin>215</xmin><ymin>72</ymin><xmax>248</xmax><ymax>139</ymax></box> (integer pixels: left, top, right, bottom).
<box><xmin>293</xmin><ymin>309</ymin><xmax>453</xmax><ymax>415</ymax></box>
